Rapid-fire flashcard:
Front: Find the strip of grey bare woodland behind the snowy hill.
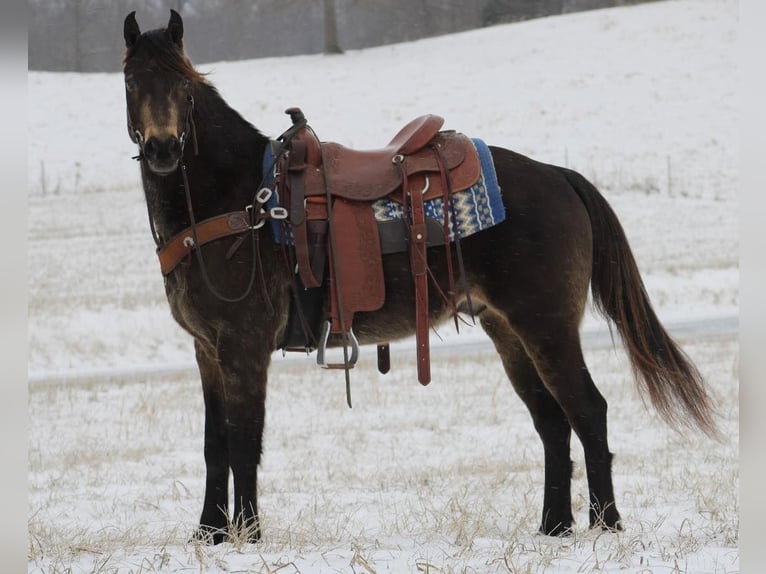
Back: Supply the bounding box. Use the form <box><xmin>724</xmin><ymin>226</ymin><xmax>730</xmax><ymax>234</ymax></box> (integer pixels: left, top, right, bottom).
<box><xmin>27</xmin><ymin>0</ymin><xmax>656</xmax><ymax>72</ymax></box>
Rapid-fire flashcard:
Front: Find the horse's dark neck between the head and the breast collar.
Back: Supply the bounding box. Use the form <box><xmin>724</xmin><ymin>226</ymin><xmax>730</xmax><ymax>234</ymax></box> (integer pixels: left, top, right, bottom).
<box><xmin>143</xmin><ymin>88</ymin><xmax>268</xmax><ymax>245</ymax></box>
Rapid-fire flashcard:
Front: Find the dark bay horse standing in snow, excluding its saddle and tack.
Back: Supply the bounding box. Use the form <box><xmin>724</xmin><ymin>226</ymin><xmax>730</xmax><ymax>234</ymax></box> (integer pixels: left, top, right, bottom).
<box><xmin>124</xmin><ymin>11</ymin><xmax>717</xmax><ymax>543</ymax></box>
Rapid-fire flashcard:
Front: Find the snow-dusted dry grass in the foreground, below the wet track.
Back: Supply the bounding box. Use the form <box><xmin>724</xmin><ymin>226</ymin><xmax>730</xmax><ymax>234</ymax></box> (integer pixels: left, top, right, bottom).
<box><xmin>28</xmin><ymin>341</ymin><xmax>739</xmax><ymax>574</ymax></box>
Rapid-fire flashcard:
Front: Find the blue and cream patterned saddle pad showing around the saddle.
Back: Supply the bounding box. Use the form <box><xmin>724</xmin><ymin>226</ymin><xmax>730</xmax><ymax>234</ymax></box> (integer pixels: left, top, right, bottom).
<box><xmin>263</xmin><ymin>138</ymin><xmax>505</xmax><ymax>245</ymax></box>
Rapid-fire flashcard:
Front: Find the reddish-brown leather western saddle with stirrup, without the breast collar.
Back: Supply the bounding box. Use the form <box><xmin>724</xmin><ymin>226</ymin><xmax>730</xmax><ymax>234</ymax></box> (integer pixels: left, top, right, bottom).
<box><xmin>277</xmin><ymin>108</ymin><xmax>481</xmax><ymax>385</ymax></box>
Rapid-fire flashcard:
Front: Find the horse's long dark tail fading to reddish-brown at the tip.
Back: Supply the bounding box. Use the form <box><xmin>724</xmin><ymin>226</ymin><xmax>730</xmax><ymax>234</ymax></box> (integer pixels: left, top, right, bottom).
<box><xmin>564</xmin><ymin>170</ymin><xmax>720</xmax><ymax>438</ymax></box>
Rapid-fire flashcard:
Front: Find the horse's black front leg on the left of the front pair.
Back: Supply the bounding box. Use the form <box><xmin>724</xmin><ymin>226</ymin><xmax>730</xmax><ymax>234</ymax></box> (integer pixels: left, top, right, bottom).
<box><xmin>194</xmin><ymin>341</ymin><xmax>229</xmax><ymax>544</ymax></box>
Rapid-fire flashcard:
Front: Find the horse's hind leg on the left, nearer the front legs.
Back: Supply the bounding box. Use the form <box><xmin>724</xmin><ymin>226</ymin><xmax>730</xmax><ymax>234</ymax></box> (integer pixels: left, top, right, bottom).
<box><xmin>480</xmin><ymin>311</ymin><xmax>572</xmax><ymax>536</ymax></box>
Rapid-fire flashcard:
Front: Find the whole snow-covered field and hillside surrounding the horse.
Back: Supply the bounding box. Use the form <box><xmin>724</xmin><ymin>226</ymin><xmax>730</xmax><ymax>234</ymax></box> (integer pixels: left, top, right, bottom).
<box><xmin>28</xmin><ymin>0</ymin><xmax>739</xmax><ymax>574</ymax></box>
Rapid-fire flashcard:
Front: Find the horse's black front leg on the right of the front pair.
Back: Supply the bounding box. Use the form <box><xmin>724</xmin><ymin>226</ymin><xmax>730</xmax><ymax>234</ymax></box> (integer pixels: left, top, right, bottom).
<box><xmin>218</xmin><ymin>338</ymin><xmax>271</xmax><ymax>542</ymax></box>
